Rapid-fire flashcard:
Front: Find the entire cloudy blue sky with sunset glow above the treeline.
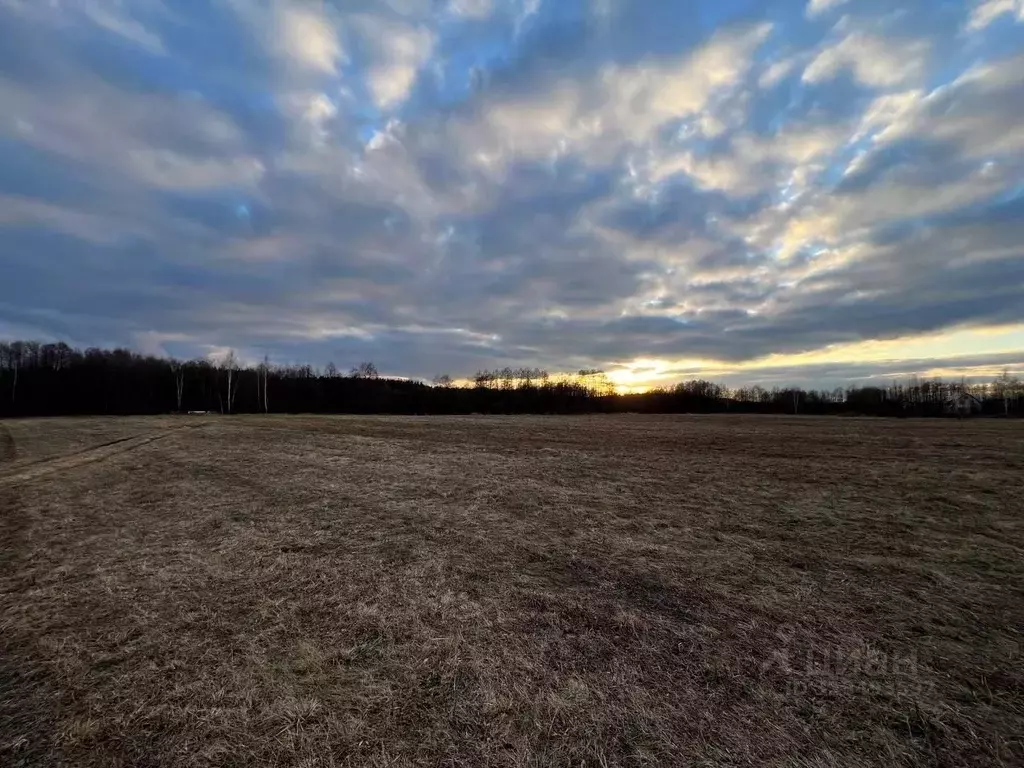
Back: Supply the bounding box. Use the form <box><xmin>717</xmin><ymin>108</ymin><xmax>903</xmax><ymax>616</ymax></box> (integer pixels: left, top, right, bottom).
<box><xmin>0</xmin><ymin>0</ymin><xmax>1024</xmax><ymax>389</ymax></box>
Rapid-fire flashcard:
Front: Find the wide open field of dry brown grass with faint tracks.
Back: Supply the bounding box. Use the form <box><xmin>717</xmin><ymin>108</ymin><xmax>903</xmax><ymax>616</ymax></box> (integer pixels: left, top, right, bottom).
<box><xmin>0</xmin><ymin>416</ymin><xmax>1024</xmax><ymax>766</ymax></box>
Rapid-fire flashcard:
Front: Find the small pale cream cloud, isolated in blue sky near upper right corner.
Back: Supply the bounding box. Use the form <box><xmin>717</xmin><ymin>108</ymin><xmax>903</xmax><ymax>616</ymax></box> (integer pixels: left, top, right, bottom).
<box><xmin>804</xmin><ymin>32</ymin><xmax>930</xmax><ymax>88</ymax></box>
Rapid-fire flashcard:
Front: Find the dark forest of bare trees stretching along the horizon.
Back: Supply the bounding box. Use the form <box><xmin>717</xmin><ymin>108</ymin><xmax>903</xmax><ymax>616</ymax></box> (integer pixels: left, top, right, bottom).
<box><xmin>0</xmin><ymin>341</ymin><xmax>1024</xmax><ymax>417</ymax></box>
